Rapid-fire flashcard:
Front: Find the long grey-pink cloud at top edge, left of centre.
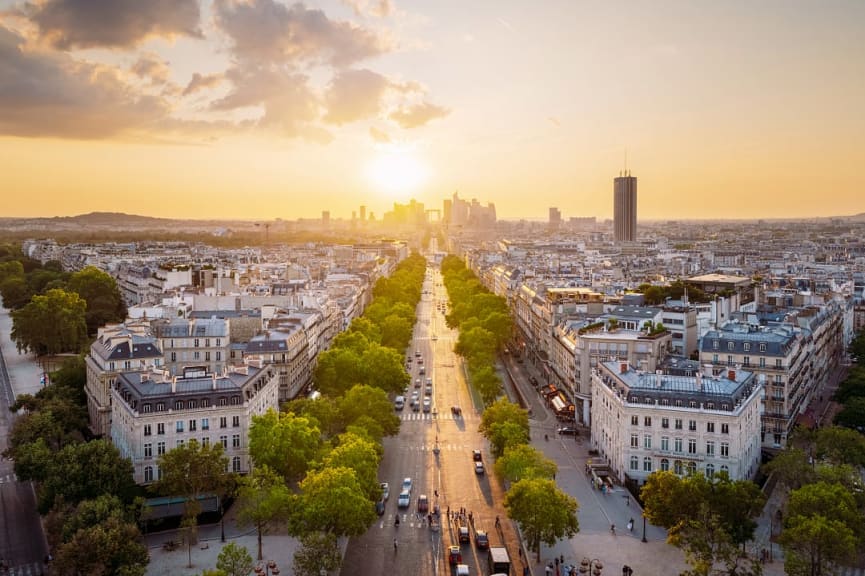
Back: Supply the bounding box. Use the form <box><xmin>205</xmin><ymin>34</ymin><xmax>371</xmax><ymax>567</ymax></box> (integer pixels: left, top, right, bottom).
<box><xmin>214</xmin><ymin>0</ymin><xmax>388</xmax><ymax>67</ymax></box>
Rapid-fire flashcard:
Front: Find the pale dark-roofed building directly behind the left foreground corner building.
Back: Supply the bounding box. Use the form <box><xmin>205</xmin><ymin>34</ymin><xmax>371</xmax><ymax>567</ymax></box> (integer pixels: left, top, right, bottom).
<box><xmin>84</xmin><ymin>323</ymin><xmax>163</xmax><ymax>436</ymax></box>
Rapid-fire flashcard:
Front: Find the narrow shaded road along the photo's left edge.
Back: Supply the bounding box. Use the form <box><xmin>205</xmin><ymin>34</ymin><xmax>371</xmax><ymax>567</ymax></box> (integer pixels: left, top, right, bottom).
<box><xmin>0</xmin><ymin>309</ymin><xmax>46</xmax><ymax>576</ymax></box>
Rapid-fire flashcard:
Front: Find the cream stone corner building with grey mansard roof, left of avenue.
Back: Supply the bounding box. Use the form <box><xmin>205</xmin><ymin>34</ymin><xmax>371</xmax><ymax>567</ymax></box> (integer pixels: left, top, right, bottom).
<box><xmin>111</xmin><ymin>364</ymin><xmax>279</xmax><ymax>484</ymax></box>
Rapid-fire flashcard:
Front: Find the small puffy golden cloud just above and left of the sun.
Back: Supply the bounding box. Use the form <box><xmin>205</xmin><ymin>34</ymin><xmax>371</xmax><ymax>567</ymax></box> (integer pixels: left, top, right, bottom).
<box><xmin>324</xmin><ymin>70</ymin><xmax>389</xmax><ymax>124</ymax></box>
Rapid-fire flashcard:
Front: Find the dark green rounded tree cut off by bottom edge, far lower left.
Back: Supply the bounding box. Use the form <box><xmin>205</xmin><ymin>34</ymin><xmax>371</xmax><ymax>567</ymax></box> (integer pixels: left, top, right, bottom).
<box><xmin>52</xmin><ymin>517</ymin><xmax>149</xmax><ymax>576</ymax></box>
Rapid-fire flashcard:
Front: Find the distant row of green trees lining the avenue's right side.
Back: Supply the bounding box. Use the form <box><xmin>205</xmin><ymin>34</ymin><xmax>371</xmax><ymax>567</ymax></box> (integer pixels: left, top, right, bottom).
<box><xmin>441</xmin><ymin>255</ymin><xmax>513</xmax><ymax>406</ymax></box>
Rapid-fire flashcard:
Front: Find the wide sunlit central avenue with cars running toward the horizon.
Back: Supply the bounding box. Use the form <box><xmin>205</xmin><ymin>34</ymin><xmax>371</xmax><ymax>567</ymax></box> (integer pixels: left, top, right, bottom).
<box><xmin>342</xmin><ymin>268</ymin><xmax>515</xmax><ymax>576</ymax></box>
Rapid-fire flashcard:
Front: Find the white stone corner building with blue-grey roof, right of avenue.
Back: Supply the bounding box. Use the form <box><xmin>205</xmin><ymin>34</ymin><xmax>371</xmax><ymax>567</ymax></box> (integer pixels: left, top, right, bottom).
<box><xmin>591</xmin><ymin>362</ymin><xmax>763</xmax><ymax>487</ymax></box>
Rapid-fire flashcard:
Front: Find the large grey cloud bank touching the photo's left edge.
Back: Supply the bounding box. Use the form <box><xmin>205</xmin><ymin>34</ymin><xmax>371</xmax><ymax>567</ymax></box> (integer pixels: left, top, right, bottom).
<box><xmin>0</xmin><ymin>26</ymin><xmax>168</xmax><ymax>138</ymax></box>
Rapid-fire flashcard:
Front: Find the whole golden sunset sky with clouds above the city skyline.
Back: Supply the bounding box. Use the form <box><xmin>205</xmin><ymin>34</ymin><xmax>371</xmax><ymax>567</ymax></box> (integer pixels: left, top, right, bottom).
<box><xmin>0</xmin><ymin>0</ymin><xmax>865</xmax><ymax>220</ymax></box>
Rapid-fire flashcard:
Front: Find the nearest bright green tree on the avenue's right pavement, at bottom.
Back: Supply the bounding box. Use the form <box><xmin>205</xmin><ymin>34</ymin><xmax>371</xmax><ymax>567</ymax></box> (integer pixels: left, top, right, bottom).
<box><xmin>505</xmin><ymin>478</ymin><xmax>580</xmax><ymax>562</ymax></box>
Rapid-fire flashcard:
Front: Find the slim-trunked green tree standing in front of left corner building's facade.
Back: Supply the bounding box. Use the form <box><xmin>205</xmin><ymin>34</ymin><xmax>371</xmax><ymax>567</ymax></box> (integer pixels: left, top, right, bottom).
<box><xmin>154</xmin><ymin>438</ymin><xmax>230</xmax><ymax>566</ymax></box>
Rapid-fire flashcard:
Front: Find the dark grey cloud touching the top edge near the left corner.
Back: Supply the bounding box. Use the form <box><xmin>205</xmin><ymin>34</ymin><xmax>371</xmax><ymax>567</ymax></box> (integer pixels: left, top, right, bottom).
<box><xmin>27</xmin><ymin>0</ymin><xmax>201</xmax><ymax>50</ymax></box>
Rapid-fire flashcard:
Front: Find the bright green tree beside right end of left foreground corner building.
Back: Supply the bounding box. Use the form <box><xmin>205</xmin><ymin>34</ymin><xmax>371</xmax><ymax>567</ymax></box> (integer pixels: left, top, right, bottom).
<box><xmin>249</xmin><ymin>410</ymin><xmax>321</xmax><ymax>483</ymax></box>
